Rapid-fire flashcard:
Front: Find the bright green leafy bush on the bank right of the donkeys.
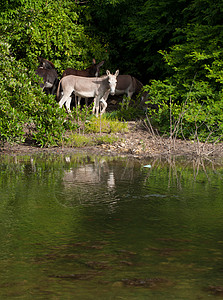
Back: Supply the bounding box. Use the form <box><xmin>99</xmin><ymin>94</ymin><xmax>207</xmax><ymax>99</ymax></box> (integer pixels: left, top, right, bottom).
<box><xmin>144</xmin><ymin>25</ymin><xmax>223</xmax><ymax>141</ymax></box>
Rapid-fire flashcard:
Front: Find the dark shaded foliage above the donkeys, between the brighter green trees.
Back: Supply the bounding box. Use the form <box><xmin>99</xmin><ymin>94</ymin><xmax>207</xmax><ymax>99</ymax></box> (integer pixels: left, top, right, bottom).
<box><xmin>87</xmin><ymin>0</ymin><xmax>192</xmax><ymax>82</ymax></box>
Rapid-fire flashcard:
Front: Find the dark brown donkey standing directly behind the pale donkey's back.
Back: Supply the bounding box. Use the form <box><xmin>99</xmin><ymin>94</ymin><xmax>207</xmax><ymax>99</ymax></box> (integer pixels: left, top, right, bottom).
<box><xmin>62</xmin><ymin>59</ymin><xmax>104</xmax><ymax>78</ymax></box>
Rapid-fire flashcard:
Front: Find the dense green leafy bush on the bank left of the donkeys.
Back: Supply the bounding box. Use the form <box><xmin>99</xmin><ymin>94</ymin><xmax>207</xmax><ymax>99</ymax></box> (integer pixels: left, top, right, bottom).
<box><xmin>0</xmin><ymin>43</ymin><xmax>72</xmax><ymax>146</ymax></box>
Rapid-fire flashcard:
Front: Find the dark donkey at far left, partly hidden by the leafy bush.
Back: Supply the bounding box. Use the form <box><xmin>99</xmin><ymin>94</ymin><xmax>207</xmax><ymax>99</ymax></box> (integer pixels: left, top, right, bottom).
<box><xmin>35</xmin><ymin>57</ymin><xmax>59</xmax><ymax>94</ymax></box>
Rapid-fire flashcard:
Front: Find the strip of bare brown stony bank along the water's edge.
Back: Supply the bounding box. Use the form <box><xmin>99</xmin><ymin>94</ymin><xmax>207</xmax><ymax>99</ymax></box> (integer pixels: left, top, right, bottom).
<box><xmin>0</xmin><ymin>122</ymin><xmax>223</xmax><ymax>158</ymax></box>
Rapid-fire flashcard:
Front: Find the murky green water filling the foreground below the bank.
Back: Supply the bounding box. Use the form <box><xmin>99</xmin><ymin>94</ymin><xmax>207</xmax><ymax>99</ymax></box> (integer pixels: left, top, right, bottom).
<box><xmin>0</xmin><ymin>154</ymin><xmax>223</xmax><ymax>300</ymax></box>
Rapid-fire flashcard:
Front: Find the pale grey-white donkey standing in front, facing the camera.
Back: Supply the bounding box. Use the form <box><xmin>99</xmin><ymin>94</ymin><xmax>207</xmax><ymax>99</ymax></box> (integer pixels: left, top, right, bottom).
<box><xmin>57</xmin><ymin>70</ymin><xmax>119</xmax><ymax>117</ymax></box>
